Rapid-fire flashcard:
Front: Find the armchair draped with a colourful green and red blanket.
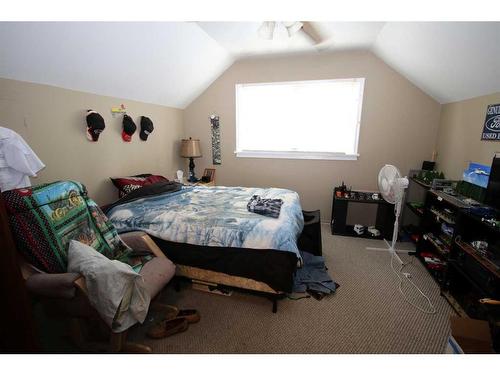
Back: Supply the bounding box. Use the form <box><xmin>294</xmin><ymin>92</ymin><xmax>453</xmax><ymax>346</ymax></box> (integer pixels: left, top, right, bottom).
<box><xmin>2</xmin><ymin>181</ymin><xmax>175</xmax><ymax>352</ymax></box>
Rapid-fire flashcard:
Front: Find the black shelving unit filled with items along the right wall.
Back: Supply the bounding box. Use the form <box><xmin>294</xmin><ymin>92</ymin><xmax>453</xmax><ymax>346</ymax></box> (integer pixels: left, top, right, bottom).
<box><xmin>416</xmin><ymin>190</ymin><xmax>500</xmax><ymax>342</ymax></box>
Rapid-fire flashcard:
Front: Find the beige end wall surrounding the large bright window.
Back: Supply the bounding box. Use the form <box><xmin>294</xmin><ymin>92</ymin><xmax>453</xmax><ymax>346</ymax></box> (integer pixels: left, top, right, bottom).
<box><xmin>184</xmin><ymin>51</ymin><xmax>440</xmax><ymax>220</ymax></box>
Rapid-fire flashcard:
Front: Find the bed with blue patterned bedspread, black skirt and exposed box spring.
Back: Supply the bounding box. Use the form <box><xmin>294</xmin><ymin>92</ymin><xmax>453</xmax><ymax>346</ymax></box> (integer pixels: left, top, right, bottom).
<box><xmin>106</xmin><ymin>182</ymin><xmax>304</xmax><ymax>308</ymax></box>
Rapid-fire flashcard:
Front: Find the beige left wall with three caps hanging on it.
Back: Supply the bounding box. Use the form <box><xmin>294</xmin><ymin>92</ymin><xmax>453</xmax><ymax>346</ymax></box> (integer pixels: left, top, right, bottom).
<box><xmin>0</xmin><ymin>79</ymin><xmax>183</xmax><ymax>204</ymax></box>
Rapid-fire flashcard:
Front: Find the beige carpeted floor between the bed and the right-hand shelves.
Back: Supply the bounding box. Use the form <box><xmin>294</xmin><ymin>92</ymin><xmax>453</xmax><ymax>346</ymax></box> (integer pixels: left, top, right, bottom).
<box><xmin>130</xmin><ymin>225</ymin><xmax>453</xmax><ymax>353</ymax></box>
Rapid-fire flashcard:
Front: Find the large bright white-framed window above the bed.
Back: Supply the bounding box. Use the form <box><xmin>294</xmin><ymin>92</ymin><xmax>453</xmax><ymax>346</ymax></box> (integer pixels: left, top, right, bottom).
<box><xmin>235</xmin><ymin>78</ymin><xmax>365</xmax><ymax>160</ymax></box>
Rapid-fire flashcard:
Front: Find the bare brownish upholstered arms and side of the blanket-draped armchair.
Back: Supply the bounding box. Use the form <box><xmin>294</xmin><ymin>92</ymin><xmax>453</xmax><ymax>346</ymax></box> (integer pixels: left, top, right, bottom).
<box><xmin>19</xmin><ymin>232</ymin><xmax>175</xmax><ymax>353</ymax></box>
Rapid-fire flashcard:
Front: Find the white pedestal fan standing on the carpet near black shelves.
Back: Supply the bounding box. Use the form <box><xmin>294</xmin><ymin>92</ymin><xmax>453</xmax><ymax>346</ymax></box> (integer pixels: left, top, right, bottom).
<box><xmin>366</xmin><ymin>164</ymin><xmax>412</xmax><ymax>265</ymax></box>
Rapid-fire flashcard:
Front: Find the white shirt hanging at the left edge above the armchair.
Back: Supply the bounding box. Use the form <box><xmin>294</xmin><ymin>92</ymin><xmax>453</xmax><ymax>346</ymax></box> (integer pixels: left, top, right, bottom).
<box><xmin>0</xmin><ymin>126</ymin><xmax>45</xmax><ymax>191</ymax></box>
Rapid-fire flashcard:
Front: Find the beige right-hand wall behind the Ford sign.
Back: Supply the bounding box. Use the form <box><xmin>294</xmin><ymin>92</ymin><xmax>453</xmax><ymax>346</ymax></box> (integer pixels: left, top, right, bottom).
<box><xmin>437</xmin><ymin>93</ymin><xmax>500</xmax><ymax>180</ymax></box>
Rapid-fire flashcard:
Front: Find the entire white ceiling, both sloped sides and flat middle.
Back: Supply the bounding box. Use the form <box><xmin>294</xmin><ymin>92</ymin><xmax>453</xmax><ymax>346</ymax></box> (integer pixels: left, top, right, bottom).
<box><xmin>0</xmin><ymin>22</ymin><xmax>500</xmax><ymax>108</ymax></box>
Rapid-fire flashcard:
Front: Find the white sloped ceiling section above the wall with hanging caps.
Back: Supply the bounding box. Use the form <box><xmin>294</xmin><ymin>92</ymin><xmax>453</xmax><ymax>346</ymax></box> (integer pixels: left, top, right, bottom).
<box><xmin>0</xmin><ymin>22</ymin><xmax>233</xmax><ymax>108</ymax></box>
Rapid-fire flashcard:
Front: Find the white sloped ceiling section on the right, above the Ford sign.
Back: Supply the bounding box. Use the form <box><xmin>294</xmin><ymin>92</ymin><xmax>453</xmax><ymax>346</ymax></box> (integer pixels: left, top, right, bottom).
<box><xmin>373</xmin><ymin>22</ymin><xmax>500</xmax><ymax>103</ymax></box>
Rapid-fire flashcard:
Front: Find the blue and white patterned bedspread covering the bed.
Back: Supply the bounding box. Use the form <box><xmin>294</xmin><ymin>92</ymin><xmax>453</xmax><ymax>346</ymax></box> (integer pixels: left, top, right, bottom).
<box><xmin>108</xmin><ymin>186</ymin><xmax>304</xmax><ymax>259</ymax></box>
